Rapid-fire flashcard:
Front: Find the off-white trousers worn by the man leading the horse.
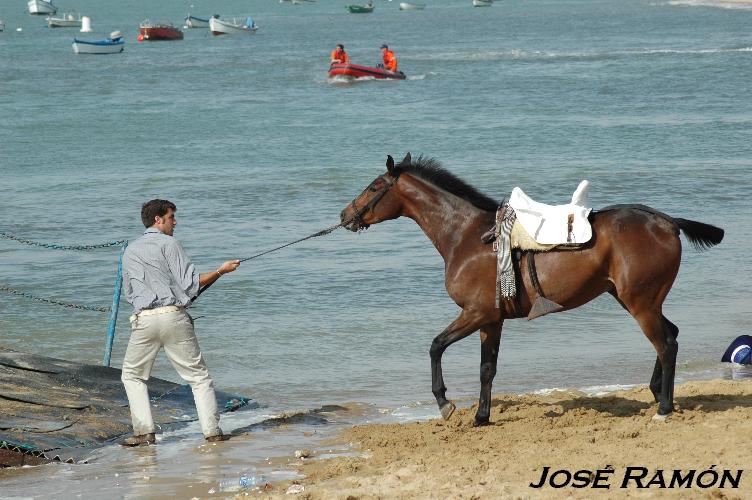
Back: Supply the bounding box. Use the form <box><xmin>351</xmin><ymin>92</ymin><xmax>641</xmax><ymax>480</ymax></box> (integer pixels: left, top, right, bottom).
<box><xmin>121</xmin><ymin>309</ymin><xmax>222</xmax><ymax>437</ymax></box>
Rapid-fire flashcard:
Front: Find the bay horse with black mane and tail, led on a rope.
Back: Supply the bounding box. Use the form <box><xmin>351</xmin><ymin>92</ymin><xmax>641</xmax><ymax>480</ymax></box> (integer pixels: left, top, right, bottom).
<box><xmin>340</xmin><ymin>153</ymin><xmax>724</xmax><ymax>426</ymax></box>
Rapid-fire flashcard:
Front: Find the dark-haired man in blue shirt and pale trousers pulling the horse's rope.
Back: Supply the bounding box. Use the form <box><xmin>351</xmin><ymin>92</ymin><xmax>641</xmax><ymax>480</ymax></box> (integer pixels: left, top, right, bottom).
<box><xmin>121</xmin><ymin>200</ymin><xmax>240</xmax><ymax>446</ymax></box>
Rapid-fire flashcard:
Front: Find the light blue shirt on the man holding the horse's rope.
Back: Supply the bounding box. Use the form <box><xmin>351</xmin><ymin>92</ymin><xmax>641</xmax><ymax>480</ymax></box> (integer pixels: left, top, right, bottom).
<box><xmin>123</xmin><ymin>228</ymin><xmax>199</xmax><ymax>313</ymax></box>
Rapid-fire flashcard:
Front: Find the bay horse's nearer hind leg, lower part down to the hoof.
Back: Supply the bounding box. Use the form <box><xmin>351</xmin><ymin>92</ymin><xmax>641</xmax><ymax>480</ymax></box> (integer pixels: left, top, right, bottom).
<box><xmin>633</xmin><ymin>310</ymin><xmax>679</xmax><ymax>416</ymax></box>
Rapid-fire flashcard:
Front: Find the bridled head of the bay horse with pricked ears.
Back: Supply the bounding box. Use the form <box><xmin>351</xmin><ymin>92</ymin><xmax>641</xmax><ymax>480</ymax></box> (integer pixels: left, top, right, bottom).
<box><xmin>340</xmin><ymin>153</ymin><xmax>412</xmax><ymax>231</ymax></box>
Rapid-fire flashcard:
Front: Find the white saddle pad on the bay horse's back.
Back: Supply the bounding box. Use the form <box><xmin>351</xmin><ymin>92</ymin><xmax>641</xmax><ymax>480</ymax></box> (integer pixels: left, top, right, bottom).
<box><xmin>509</xmin><ymin>181</ymin><xmax>593</xmax><ymax>245</ymax></box>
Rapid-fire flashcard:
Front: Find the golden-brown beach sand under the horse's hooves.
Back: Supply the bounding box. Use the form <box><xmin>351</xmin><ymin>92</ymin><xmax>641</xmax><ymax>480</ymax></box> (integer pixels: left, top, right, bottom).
<box><xmin>268</xmin><ymin>380</ymin><xmax>752</xmax><ymax>499</ymax></box>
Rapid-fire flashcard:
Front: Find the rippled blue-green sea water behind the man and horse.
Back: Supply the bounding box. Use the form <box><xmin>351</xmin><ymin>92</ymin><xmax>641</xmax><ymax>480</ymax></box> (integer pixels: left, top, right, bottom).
<box><xmin>0</xmin><ymin>0</ymin><xmax>752</xmax><ymax>496</ymax></box>
